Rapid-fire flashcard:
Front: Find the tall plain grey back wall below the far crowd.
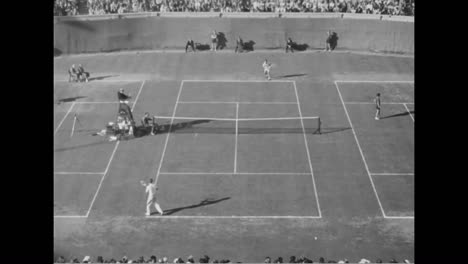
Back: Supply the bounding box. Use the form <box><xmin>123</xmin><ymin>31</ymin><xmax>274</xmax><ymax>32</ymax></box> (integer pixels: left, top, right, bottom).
<box><xmin>54</xmin><ymin>13</ymin><xmax>414</xmax><ymax>54</ymax></box>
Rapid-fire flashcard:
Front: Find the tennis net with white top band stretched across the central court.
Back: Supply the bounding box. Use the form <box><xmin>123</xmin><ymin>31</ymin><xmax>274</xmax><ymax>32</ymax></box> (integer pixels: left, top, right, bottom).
<box><xmin>152</xmin><ymin>116</ymin><xmax>322</xmax><ymax>134</ymax></box>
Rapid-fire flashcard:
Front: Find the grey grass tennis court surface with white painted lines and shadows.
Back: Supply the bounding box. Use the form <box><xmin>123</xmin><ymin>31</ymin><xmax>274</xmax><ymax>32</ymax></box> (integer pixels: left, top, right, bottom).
<box><xmin>54</xmin><ymin>53</ymin><xmax>414</xmax><ymax>262</ymax></box>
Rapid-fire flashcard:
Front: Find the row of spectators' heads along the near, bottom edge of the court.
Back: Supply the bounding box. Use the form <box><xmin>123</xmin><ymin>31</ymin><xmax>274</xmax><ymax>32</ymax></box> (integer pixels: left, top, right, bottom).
<box><xmin>55</xmin><ymin>255</ymin><xmax>411</xmax><ymax>264</ymax></box>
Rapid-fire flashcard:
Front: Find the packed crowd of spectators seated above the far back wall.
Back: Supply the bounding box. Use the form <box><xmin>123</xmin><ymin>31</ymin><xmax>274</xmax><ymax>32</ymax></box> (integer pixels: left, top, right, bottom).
<box><xmin>54</xmin><ymin>0</ymin><xmax>414</xmax><ymax>16</ymax></box>
